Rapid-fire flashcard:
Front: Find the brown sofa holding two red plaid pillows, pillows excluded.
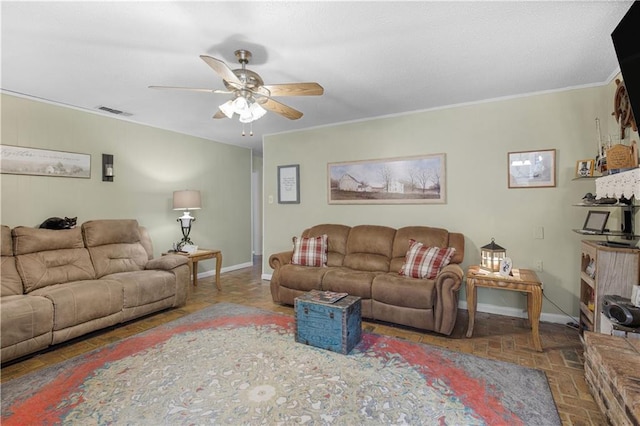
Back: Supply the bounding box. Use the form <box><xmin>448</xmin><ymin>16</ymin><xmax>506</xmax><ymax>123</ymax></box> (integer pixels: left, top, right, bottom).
<box><xmin>269</xmin><ymin>224</ymin><xmax>464</xmax><ymax>335</ymax></box>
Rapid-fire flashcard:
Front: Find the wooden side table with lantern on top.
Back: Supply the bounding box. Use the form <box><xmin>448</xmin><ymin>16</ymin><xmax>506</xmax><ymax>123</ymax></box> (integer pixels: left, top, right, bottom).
<box><xmin>467</xmin><ymin>266</ymin><xmax>542</xmax><ymax>352</ymax></box>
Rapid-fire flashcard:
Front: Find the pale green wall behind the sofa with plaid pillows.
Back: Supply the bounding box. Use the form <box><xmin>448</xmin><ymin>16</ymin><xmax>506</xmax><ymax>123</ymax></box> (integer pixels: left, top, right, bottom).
<box><xmin>263</xmin><ymin>78</ymin><xmax>638</xmax><ymax>321</ymax></box>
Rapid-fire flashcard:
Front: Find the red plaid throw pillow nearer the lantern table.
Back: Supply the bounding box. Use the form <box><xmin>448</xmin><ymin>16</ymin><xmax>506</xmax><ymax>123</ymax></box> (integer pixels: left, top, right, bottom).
<box><xmin>399</xmin><ymin>240</ymin><xmax>456</xmax><ymax>280</ymax></box>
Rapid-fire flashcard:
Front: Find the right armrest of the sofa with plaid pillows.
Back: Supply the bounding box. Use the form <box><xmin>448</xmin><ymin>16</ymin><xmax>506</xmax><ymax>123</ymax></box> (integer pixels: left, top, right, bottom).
<box><xmin>434</xmin><ymin>263</ymin><xmax>464</xmax><ymax>336</ymax></box>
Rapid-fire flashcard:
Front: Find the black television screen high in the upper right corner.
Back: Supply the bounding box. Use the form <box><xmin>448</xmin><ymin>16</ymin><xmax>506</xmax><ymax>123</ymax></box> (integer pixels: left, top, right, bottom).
<box><xmin>611</xmin><ymin>1</ymin><xmax>640</xmax><ymax>130</ymax></box>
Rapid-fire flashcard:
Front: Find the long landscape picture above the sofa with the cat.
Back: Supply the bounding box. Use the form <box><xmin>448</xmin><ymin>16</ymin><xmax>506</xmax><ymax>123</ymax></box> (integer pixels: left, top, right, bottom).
<box><xmin>0</xmin><ymin>145</ymin><xmax>91</xmax><ymax>179</ymax></box>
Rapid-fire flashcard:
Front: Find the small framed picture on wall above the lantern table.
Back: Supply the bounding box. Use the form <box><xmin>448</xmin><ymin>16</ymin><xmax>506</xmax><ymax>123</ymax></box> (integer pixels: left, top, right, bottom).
<box><xmin>507</xmin><ymin>149</ymin><xmax>556</xmax><ymax>188</ymax></box>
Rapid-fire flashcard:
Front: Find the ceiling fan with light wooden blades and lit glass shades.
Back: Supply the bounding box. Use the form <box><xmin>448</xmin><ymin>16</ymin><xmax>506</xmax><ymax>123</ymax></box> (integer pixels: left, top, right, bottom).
<box><xmin>149</xmin><ymin>49</ymin><xmax>324</xmax><ymax>123</ymax></box>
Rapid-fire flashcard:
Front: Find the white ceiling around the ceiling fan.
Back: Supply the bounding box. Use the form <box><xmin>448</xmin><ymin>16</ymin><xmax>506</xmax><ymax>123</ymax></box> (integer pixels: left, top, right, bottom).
<box><xmin>0</xmin><ymin>1</ymin><xmax>632</xmax><ymax>151</ymax></box>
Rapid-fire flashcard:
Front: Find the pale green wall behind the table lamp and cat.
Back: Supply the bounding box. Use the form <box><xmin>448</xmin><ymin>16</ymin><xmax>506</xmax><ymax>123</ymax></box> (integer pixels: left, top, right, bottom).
<box><xmin>0</xmin><ymin>94</ymin><xmax>252</xmax><ymax>273</ymax></box>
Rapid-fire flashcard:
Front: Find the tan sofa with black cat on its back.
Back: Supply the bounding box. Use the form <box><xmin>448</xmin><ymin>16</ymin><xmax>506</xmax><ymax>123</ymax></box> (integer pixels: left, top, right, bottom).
<box><xmin>0</xmin><ymin>220</ymin><xmax>190</xmax><ymax>362</ymax></box>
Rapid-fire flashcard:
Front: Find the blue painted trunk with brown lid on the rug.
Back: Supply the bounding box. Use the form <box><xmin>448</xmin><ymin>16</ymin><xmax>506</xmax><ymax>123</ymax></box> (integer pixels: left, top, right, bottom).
<box><xmin>294</xmin><ymin>294</ymin><xmax>362</xmax><ymax>354</ymax></box>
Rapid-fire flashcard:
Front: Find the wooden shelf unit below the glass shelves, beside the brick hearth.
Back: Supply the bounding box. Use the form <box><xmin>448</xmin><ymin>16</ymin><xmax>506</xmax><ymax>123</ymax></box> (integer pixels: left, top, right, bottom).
<box><xmin>580</xmin><ymin>240</ymin><xmax>640</xmax><ymax>333</ymax></box>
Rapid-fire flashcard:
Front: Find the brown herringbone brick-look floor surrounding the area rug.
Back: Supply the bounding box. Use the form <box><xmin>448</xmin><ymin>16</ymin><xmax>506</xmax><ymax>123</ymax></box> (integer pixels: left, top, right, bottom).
<box><xmin>1</xmin><ymin>258</ymin><xmax>606</xmax><ymax>426</ymax></box>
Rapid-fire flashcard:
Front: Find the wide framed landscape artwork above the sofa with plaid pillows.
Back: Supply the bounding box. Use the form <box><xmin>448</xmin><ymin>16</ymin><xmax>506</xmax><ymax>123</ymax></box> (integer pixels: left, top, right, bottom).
<box><xmin>327</xmin><ymin>154</ymin><xmax>446</xmax><ymax>204</ymax></box>
